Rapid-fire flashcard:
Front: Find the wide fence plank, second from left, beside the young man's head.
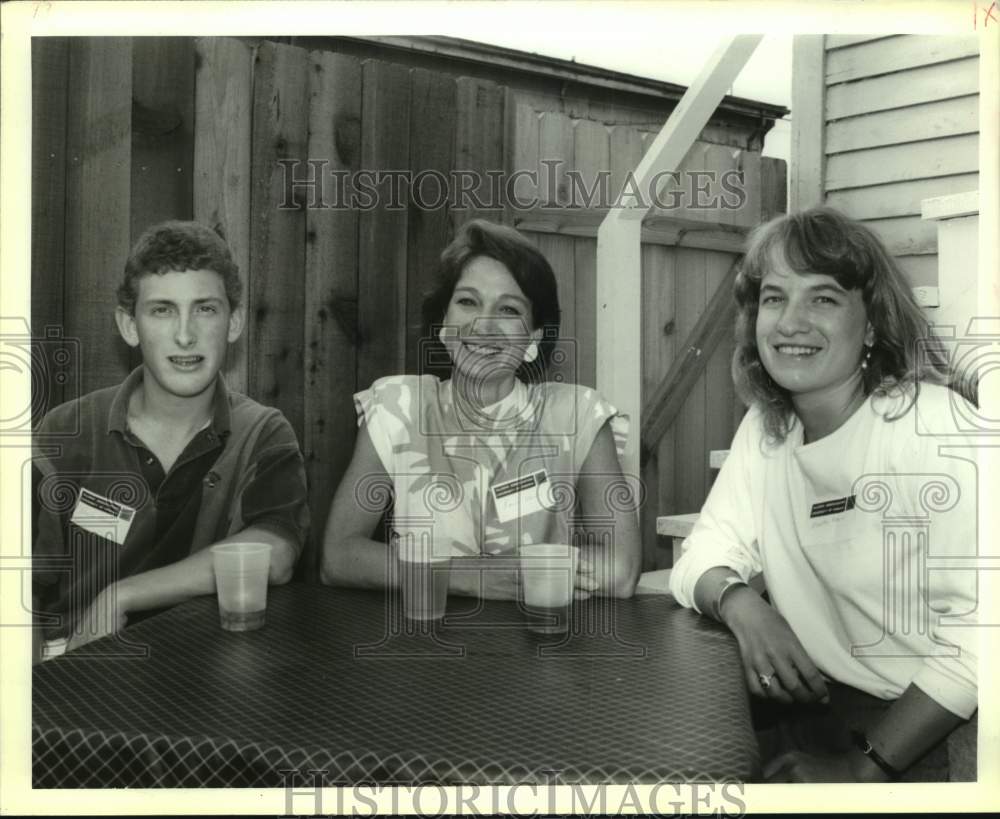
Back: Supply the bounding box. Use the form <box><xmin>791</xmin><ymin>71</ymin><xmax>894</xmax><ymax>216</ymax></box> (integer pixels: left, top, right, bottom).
<box><xmin>65</xmin><ymin>37</ymin><xmax>132</xmax><ymax>392</ymax></box>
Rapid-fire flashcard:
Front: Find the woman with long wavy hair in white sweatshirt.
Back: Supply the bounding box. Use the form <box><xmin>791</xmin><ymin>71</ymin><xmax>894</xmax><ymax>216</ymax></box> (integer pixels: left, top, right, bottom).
<box><xmin>670</xmin><ymin>208</ymin><xmax>977</xmax><ymax>782</ymax></box>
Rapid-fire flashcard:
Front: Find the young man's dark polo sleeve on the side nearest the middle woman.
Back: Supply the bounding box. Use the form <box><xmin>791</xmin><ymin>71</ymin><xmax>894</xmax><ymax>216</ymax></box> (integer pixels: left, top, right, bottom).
<box><xmin>240</xmin><ymin>414</ymin><xmax>309</xmax><ymax>553</ymax></box>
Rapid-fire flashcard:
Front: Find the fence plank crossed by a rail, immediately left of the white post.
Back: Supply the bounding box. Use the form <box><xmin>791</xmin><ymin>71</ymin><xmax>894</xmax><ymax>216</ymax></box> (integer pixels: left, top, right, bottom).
<box><xmin>573</xmin><ymin>120</ymin><xmax>613</xmax><ymax>386</ymax></box>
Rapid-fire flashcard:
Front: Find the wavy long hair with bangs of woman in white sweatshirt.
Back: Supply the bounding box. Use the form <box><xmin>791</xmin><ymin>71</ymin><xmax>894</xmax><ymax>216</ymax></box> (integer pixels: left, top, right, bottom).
<box><xmin>732</xmin><ymin>207</ymin><xmax>976</xmax><ymax>442</ymax></box>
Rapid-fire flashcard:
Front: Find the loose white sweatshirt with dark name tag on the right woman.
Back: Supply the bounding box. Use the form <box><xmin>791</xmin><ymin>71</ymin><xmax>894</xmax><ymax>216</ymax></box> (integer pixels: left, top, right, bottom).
<box><xmin>670</xmin><ymin>384</ymin><xmax>979</xmax><ymax>718</ymax></box>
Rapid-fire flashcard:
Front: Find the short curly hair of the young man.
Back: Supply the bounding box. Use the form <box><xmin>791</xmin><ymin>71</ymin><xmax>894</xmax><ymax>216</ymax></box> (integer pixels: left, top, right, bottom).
<box><xmin>118</xmin><ymin>221</ymin><xmax>243</xmax><ymax>315</ymax></box>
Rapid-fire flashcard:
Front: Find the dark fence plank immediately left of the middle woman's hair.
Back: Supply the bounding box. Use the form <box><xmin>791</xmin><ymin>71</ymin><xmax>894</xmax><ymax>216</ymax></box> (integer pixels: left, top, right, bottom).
<box><xmin>406</xmin><ymin>68</ymin><xmax>457</xmax><ymax>374</ymax></box>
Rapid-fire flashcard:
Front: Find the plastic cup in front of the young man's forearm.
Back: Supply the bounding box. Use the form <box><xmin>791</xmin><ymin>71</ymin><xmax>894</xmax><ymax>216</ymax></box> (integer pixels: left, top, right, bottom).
<box><xmin>212</xmin><ymin>543</ymin><xmax>271</xmax><ymax>631</ymax></box>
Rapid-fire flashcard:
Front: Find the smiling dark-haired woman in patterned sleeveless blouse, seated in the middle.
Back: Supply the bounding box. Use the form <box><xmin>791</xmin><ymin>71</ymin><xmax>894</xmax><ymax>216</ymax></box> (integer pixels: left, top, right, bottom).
<box><xmin>321</xmin><ymin>220</ymin><xmax>640</xmax><ymax>598</ymax></box>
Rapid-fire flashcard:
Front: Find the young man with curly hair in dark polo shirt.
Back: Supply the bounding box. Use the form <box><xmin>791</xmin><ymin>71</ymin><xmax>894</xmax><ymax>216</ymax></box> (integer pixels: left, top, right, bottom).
<box><xmin>33</xmin><ymin>222</ymin><xmax>309</xmax><ymax>660</ymax></box>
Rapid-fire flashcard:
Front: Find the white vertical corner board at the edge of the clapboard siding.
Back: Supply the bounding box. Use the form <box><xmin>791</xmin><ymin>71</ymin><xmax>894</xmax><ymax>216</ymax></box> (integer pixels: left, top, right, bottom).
<box><xmin>789</xmin><ymin>34</ymin><xmax>826</xmax><ymax>210</ymax></box>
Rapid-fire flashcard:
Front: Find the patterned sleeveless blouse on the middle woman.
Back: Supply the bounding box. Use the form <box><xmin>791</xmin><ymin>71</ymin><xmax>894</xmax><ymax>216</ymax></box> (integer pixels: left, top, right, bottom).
<box><xmin>354</xmin><ymin>375</ymin><xmax>628</xmax><ymax>557</ymax></box>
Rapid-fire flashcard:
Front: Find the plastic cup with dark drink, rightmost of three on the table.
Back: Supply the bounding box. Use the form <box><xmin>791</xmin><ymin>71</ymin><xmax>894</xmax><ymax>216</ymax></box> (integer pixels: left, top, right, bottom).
<box><xmin>519</xmin><ymin>543</ymin><xmax>580</xmax><ymax>634</ymax></box>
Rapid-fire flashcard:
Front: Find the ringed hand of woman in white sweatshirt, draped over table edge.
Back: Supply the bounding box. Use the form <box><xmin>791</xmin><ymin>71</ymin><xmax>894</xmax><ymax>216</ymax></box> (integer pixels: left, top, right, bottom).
<box><xmin>722</xmin><ymin>587</ymin><xmax>829</xmax><ymax>705</ymax></box>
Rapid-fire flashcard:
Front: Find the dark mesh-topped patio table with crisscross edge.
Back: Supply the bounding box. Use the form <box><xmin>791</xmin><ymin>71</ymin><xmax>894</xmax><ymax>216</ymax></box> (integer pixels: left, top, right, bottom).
<box><xmin>32</xmin><ymin>583</ymin><xmax>759</xmax><ymax>788</ymax></box>
